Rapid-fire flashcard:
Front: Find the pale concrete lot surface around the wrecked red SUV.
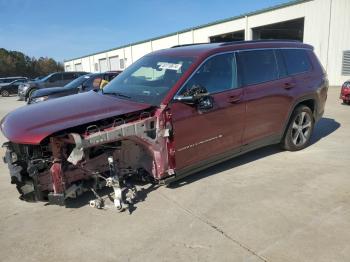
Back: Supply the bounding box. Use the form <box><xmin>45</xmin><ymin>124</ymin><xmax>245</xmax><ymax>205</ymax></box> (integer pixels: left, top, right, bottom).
<box><xmin>0</xmin><ymin>88</ymin><xmax>350</xmax><ymax>262</ymax></box>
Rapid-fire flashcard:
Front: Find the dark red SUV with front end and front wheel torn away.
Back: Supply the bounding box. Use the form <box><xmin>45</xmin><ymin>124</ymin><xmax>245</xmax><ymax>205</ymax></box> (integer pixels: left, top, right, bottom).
<box><xmin>1</xmin><ymin>41</ymin><xmax>328</xmax><ymax>209</ymax></box>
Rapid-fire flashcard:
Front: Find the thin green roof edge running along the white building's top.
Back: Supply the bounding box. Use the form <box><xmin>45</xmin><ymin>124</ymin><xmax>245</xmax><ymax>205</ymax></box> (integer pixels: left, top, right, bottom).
<box><xmin>64</xmin><ymin>0</ymin><xmax>313</xmax><ymax>62</ymax></box>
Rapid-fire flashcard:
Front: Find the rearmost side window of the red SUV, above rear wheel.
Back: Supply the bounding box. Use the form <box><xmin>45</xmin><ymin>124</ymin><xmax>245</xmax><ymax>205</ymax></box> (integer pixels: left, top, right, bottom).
<box><xmin>282</xmin><ymin>49</ymin><xmax>311</xmax><ymax>75</ymax></box>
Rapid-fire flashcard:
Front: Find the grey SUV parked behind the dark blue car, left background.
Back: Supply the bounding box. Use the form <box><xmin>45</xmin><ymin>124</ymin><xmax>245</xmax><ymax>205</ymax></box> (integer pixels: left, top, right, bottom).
<box><xmin>18</xmin><ymin>72</ymin><xmax>87</xmax><ymax>101</ymax></box>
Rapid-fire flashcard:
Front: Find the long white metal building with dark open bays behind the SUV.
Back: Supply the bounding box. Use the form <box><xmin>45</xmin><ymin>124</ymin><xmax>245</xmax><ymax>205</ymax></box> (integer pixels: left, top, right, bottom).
<box><xmin>64</xmin><ymin>0</ymin><xmax>350</xmax><ymax>85</ymax></box>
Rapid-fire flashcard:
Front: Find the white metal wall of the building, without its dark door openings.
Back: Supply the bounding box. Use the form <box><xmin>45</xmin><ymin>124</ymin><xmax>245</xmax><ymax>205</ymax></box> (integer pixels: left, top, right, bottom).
<box><xmin>65</xmin><ymin>0</ymin><xmax>350</xmax><ymax>85</ymax></box>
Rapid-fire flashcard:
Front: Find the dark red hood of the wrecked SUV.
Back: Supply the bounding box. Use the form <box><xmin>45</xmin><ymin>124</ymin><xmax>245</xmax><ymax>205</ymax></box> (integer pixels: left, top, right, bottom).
<box><xmin>1</xmin><ymin>91</ymin><xmax>152</xmax><ymax>145</ymax></box>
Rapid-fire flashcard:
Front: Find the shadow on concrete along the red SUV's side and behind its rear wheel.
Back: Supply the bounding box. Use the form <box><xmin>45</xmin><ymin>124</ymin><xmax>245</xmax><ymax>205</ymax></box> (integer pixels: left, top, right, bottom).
<box><xmin>168</xmin><ymin>118</ymin><xmax>340</xmax><ymax>188</ymax></box>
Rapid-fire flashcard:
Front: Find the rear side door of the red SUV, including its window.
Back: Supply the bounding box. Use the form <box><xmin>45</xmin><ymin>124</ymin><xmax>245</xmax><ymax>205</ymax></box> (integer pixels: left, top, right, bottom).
<box><xmin>238</xmin><ymin>49</ymin><xmax>295</xmax><ymax>145</ymax></box>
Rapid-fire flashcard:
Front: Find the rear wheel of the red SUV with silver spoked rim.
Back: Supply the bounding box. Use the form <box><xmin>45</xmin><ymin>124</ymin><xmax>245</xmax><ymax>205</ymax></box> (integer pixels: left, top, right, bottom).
<box><xmin>281</xmin><ymin>106</ymin><xmax>315</xmax><ymax>151</ymax></box>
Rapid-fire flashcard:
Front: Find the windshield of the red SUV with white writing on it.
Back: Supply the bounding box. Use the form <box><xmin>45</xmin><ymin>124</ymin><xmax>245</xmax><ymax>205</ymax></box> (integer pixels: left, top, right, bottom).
<box><xmin>103</xmin><ymin>55</ymin><xmax>194</xmax><ymax>106</ymax></box>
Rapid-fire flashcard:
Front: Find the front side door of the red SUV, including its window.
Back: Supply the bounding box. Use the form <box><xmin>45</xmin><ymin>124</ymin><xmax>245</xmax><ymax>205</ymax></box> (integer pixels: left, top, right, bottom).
<box><xmin>171</xmin><ymin>53</ymin><xmax>245</xmax><ymax>170</ymax></box>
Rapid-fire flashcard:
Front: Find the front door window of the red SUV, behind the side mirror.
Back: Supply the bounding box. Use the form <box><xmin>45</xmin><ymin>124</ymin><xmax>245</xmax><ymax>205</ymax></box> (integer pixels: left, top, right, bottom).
<box><xmin>180</xmin><ymin>53</ymin><xmax>237</xmax><ymax>94</ymax></box>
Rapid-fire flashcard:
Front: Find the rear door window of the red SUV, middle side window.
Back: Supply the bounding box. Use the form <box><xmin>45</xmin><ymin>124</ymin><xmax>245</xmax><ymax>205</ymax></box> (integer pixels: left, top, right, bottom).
<box><xmin>238</xmin><ymin>50</ymin><xmax>278</xmax><ymax>86</ymax></box>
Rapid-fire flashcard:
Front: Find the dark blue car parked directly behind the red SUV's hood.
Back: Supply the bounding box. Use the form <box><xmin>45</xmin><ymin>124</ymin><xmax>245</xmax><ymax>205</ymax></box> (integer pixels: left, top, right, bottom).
<box><xmin>28</xmin><ymin>71</ymin><xmax>120</xmax><ymax>104</ymax></box>
